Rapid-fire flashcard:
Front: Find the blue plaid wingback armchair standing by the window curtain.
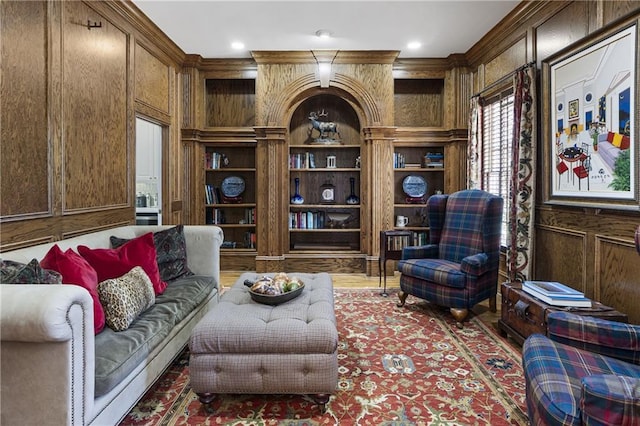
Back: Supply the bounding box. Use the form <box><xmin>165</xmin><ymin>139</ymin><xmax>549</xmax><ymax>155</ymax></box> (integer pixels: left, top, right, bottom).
<box><xmin>398</xmin><ymin>189</ymin><xmax>503</xmax><ymax>328</ymax></box>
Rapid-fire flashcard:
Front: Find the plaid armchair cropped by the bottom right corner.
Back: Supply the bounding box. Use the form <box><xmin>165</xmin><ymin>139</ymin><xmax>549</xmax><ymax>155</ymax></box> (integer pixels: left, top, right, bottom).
<box><xmin>522</xmin><ymin>312</ymin><xmax>640</xmax><ymax>426</ymax></box>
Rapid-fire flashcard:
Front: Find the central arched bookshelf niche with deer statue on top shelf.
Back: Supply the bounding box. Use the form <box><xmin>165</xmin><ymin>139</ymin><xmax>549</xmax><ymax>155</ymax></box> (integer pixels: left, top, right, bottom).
<box><xmin>288</xmin><ymin>94</ymin><xmax>362</xmax><ymax>254</ymax></box>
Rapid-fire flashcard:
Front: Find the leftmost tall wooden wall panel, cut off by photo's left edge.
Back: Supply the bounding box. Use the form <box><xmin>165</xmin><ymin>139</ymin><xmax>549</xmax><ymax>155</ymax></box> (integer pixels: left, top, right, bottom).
<box><xmin>0</xmin><ymin>1</ymin><xmax>52</xmax><ymax>218</ymax></box>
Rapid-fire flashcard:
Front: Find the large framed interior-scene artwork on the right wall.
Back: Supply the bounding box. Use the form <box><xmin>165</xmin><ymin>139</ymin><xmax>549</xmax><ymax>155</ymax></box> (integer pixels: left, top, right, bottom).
<box><xmin>542</xmin><ymin>18</ymin><xmax>640</xmax><ymax>210</ymax></box>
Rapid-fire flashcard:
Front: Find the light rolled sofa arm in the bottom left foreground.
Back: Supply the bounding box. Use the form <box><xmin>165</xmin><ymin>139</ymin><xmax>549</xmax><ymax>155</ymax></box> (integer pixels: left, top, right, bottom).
<box><xmin>0</xmin><ymin>284</ymin><xmax>95</xmax><ymax>424</ymax></box>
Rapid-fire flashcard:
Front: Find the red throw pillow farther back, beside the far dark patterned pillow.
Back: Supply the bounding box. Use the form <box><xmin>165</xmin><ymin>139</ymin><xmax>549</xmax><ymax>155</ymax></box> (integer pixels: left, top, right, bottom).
<box><xmin>78</xmin><ymin>232</ymin><xmax>167</xmax><ymax>296</ymax></box>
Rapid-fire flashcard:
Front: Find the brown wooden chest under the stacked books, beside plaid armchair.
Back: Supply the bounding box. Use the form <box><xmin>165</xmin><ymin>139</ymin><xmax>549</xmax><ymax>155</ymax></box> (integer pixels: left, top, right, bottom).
<box><xmin>498</xmin><ymin>282</ymin><xmax>629</xmax><ymax>344</ymax></box>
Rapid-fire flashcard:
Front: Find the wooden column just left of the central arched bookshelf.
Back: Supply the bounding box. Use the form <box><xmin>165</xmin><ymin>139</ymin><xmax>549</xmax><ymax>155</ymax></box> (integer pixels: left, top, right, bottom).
<box><xmin>254</xmin><ymin>127</ymin><xmax>289</xmax><ymax>272</ymax></box>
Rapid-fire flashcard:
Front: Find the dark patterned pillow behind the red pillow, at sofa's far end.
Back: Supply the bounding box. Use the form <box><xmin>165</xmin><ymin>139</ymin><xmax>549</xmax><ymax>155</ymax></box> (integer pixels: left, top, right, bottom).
<box><xmin>110</xmin><ymin>225</ymin><xmax>193</xmax><ymax>281</ymax></box>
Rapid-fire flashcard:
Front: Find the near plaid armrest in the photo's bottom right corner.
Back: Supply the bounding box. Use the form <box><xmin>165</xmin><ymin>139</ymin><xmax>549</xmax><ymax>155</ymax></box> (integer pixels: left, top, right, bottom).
<box><xmin>580</xmin><ymin>374</ymin><xmax>640</xmax><ymax>425</ymax></box>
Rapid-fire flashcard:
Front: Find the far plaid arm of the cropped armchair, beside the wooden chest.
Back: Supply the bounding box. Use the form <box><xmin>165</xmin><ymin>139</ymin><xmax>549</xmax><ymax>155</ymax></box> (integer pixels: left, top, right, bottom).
<box><xmin>547</xmin><ymin>311</ymin><xmax>640</xmax><ymax>365</ymax></box>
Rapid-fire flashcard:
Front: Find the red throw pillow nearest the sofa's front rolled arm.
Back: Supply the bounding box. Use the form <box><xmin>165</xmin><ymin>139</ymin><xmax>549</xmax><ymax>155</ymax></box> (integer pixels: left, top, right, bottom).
<box><xmin>40</xmin><ymin>244</ymin><xmax>105</xmax><ymax>334</ymax></box>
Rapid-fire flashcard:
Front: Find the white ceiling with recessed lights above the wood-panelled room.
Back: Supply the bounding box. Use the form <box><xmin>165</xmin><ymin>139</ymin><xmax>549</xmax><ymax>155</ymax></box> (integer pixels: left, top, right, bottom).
<box><xmin>133</xmin><ymin>0</ymin><xmax>520</xmax><ymax>58</ymax></box>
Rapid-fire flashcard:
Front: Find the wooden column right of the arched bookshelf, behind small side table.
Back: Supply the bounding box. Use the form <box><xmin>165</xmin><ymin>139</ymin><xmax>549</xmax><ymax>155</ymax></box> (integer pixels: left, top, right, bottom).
<box><xmin>360</xmin><ymin>126</ymin><xmax>396</xmax><ymax>275</ymax></box>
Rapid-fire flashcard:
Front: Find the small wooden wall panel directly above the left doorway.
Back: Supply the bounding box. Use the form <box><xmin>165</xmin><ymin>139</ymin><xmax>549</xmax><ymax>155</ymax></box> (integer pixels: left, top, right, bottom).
<box><xmin>134</xmin><ymin>43</ymin><xmax>171</xmax><ymax>114</ymax></box>
